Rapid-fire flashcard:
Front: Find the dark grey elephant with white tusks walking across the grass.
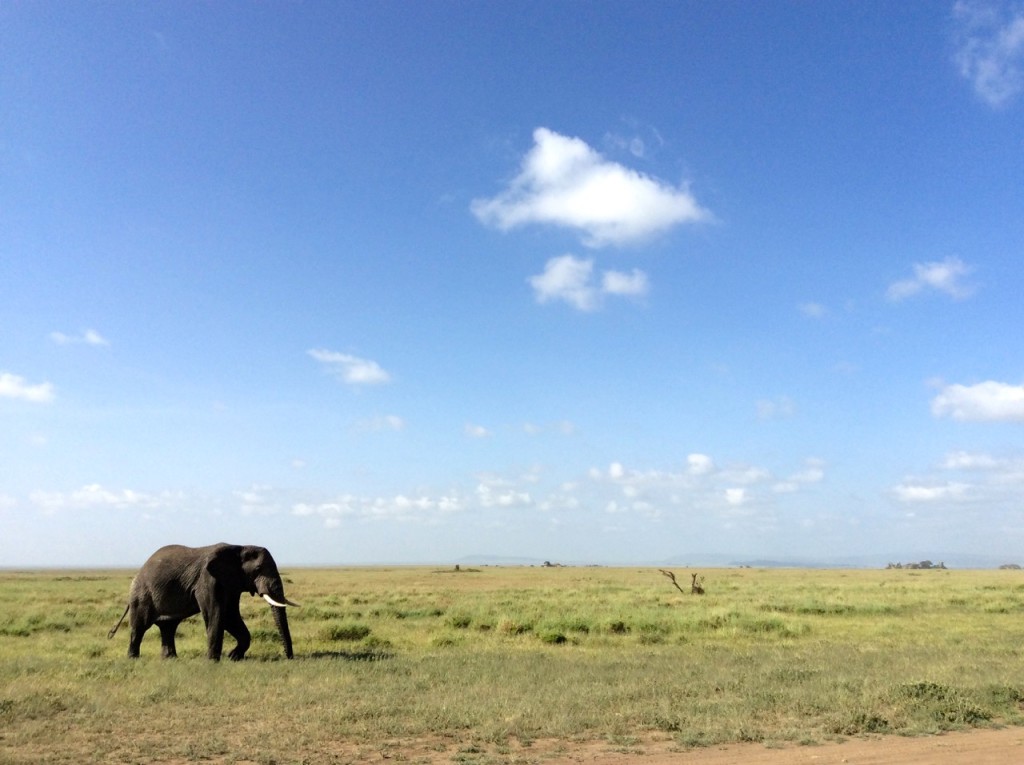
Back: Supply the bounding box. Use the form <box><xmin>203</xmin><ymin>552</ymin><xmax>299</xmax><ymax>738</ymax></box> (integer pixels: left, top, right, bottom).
<box><xmin>108</xmin><ymin>543</ymin><xmax>298</xmax><ymax>662</ymax></box>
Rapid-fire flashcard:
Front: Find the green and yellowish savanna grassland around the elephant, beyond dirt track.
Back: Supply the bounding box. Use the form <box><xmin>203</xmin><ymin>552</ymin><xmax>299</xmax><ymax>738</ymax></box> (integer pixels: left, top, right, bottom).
<box><xmin>0</xmin><ymin>567</ymin><xmax>1024</xmax><ymax>765</ymax></box>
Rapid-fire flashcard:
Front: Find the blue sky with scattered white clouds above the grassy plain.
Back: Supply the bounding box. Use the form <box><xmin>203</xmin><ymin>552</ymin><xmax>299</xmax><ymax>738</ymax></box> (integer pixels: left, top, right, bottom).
<box><xmin>0</xmin><ymin>0</ymin><xmax>1024</xmax><ymax>565</ymax></box>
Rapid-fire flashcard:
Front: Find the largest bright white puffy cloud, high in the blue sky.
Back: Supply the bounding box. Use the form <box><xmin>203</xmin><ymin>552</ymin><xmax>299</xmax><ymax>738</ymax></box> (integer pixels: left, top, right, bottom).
<box><xmin>470</xmin><ymin>128</ymin><xmax>711</xmax><ymax>247</ymax></box>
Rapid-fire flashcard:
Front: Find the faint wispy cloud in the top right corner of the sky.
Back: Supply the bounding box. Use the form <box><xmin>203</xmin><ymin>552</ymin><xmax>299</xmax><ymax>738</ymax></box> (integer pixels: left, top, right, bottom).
<box><xmin>953</xmin><ymin>0</ymin><xmax>1024</xmax><ymax>109</ymax></box>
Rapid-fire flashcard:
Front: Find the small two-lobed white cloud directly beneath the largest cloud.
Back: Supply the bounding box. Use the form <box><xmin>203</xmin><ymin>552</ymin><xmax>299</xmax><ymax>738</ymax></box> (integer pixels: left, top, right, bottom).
<box><xmin>528</xmin><ymin>254</ymin><xmax>648</xmax><ymax>311</ymax></box>
